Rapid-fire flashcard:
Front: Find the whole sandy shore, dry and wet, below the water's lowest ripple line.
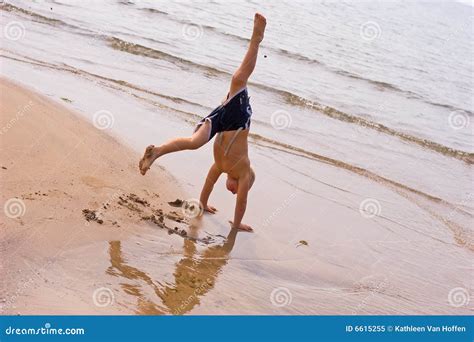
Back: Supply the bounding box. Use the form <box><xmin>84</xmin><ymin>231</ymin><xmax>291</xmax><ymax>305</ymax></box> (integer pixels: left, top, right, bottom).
<box><xmin>0</xmin><ymin>79</ymin><xmax>472</xmax><ymax>314</ymax></box>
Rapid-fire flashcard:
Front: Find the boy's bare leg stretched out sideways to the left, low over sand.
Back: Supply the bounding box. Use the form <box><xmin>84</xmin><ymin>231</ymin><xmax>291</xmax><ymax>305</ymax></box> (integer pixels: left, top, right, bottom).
<box><xmin>138</xmin><ymin>121</ymin><xmax>211</xmax><ymax>175</ymax></box>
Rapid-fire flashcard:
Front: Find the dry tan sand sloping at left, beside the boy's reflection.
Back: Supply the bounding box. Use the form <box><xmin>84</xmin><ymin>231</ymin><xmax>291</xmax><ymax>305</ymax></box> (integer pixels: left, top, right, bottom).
<box><xmin>0</xmin><ymin>79</ymin><xmax>206</xmax><ymax>314</ymax></box>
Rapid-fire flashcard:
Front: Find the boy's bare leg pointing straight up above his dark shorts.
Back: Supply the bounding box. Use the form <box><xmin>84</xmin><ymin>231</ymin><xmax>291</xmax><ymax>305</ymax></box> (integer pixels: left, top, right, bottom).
<box><xmin>229</xmin><ymin>13</ymin><xmax>267</xmax><ymax>98</ymax></box>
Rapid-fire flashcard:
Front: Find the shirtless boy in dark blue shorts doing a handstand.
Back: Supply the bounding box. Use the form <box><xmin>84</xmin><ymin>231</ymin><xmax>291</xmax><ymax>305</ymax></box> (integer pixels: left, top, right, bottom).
<box><xmin>139</xmin><ymin>13</ymin><xmax>266</xmax><ymax>232</ymax></box>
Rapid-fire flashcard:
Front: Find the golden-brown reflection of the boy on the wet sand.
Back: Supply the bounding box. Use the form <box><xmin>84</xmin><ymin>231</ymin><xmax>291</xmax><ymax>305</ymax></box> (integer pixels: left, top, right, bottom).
<box><xmin>106</xmin><ymin>229</ymin><xmax>237</xmax><ymax>315</ymax></box>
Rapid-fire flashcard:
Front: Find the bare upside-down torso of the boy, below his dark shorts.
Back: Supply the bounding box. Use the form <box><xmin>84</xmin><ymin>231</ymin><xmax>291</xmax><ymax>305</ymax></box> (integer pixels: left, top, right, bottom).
<box><xmin>214</xmin><ymin>129</ymin><xmax>250</xmax><ymax>179</ymax></box>
